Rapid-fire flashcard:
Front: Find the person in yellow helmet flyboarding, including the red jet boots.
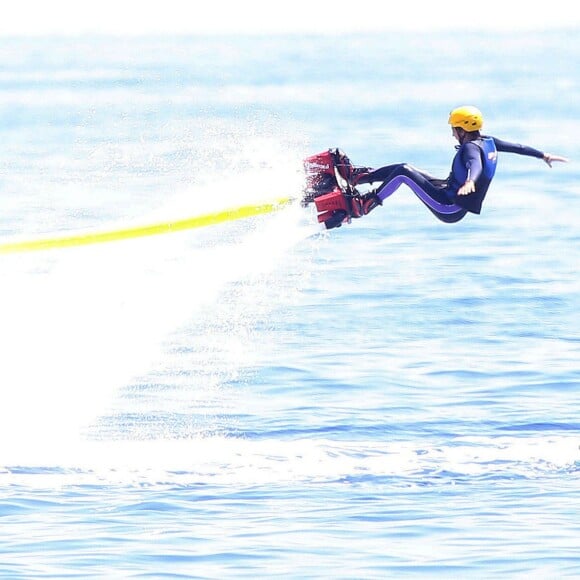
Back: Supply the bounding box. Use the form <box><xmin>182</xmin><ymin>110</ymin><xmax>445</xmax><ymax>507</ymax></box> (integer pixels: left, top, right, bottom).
<box><xmin>305</xmin><ymin>105</ymin><xmax>568</xmax><ymax>229</ymax></box>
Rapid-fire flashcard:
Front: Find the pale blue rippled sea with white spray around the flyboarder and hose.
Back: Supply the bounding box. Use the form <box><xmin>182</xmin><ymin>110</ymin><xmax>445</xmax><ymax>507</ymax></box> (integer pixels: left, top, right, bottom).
<box><xmin>0</xmin><ymin>30</ymin><xmax>580</xmax><ymax>578</ymax></box>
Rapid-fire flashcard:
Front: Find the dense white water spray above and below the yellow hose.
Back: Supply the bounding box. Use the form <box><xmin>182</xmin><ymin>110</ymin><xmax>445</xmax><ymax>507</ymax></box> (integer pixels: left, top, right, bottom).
<box><xmin>0</xmin><ymin>139</ymin><xmax>316</xmax><ymax>462</ymax></box>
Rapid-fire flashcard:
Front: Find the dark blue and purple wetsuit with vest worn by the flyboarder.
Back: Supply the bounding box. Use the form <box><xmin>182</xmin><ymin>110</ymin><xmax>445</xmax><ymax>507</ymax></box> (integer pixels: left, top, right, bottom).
<box><xmin>356</xmin><ymin>136</ymin><xmax>544</xmax><ymax>223</ymax></box>
